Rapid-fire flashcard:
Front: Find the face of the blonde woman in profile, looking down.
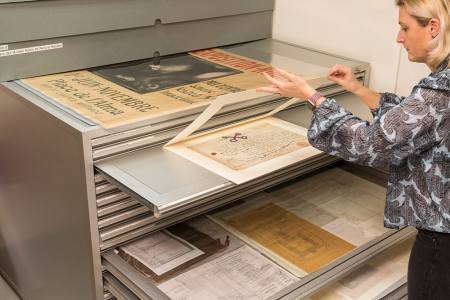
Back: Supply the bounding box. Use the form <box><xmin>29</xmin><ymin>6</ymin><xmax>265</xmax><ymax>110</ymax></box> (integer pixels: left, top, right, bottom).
<box><xmin>397</xmin><ymin>6</ymin><xmax>433</xmax><ymax>63</ymax></box>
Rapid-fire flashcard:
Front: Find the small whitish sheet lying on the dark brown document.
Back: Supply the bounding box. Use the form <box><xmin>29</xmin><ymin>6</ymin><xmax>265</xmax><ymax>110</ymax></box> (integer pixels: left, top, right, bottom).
<box><xmin>120</xmin><ymin>231</ymin><xmax>204</xmax><ymax>275</ymax></box>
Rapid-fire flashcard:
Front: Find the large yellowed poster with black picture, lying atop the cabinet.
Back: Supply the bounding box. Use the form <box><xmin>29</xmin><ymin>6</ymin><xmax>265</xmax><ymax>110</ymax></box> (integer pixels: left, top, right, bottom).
<box><xmin>21</xmin><ymin>49</ymin><xmax>284</xmax><ymax>128</ymax></box>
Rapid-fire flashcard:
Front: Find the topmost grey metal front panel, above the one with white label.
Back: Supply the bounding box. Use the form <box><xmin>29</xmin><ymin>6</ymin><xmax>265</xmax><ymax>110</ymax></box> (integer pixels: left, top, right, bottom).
<box><xmin>0</xmin><ymin>0</ymin><xmax>274</xmax><ymax>44</ymax></box>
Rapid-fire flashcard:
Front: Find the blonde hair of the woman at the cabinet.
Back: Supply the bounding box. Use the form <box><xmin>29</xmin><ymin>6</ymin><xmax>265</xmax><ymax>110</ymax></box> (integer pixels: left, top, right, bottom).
<box><xmin>395</xmin><ymin>0</ymin><xmax>450</xmax><ymax>71</ymax></box>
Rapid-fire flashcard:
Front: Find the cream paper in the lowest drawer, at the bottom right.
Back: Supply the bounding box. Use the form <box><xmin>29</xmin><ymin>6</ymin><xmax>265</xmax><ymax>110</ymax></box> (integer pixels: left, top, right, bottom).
<box><xmin>310</xmin><ymin>238</ymin><xmax>414</xmax><ymax>300</ymax></box>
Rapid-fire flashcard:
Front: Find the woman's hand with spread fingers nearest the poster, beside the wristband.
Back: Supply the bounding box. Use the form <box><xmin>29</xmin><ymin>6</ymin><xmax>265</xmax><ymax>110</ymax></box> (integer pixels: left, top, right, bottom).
<box><xmin>256</xmin><ymin>68</ymin><xmax>316</xmax><ymax>99</ymax></box>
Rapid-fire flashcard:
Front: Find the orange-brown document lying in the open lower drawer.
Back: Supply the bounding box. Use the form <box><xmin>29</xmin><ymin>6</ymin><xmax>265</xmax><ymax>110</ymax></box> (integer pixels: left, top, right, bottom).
<box><xmin>211</xmin><ymin>203</ymin><xmax>355</xmax><ymax>277</ymax></box>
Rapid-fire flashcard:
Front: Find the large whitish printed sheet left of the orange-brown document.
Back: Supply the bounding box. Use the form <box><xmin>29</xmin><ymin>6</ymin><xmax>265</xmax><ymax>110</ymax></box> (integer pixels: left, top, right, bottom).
<box><xmin>158</xmin><ymin>246</ymin><xmax>296</xmax><ymax>300</ymax></box>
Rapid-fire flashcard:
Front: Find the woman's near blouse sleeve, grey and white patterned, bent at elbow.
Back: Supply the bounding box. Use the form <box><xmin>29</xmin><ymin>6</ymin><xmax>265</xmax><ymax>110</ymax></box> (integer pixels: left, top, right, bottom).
<box><xmin>308</xmin><ymin>88</ymin><xmax>450</xmax><ymax>166</ymax></box>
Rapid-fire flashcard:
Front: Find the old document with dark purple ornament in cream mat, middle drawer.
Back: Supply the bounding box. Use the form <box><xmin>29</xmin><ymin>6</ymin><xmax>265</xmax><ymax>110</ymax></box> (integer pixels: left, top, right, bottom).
<box><xmin>166</xmin><ymin>117</ymin><xmax>321</xmax><ymax>184</ymax></box>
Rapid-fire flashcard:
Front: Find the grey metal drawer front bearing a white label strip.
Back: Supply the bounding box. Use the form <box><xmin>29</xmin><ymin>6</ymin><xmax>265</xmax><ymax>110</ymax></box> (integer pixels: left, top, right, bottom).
<box><xmin>0</xmin><ymin>11</ymin><xmax>272</xmax><ymax>81</ymax></box>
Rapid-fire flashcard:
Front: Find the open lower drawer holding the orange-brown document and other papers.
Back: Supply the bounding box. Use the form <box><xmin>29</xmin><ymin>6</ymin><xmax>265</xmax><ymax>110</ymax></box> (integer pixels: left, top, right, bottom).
<box><xmin>102</xmin><ymin>163</ymin><xmax>414</xmax><ymax>299</ymax></box>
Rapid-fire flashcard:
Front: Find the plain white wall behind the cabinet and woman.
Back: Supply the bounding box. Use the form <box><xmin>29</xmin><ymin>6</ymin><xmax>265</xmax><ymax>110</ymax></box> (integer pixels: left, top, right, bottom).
<box><xmin>273</xmin><ymin>0</ymin><xmax>428</xmax><ymax>95</ymax></box>
